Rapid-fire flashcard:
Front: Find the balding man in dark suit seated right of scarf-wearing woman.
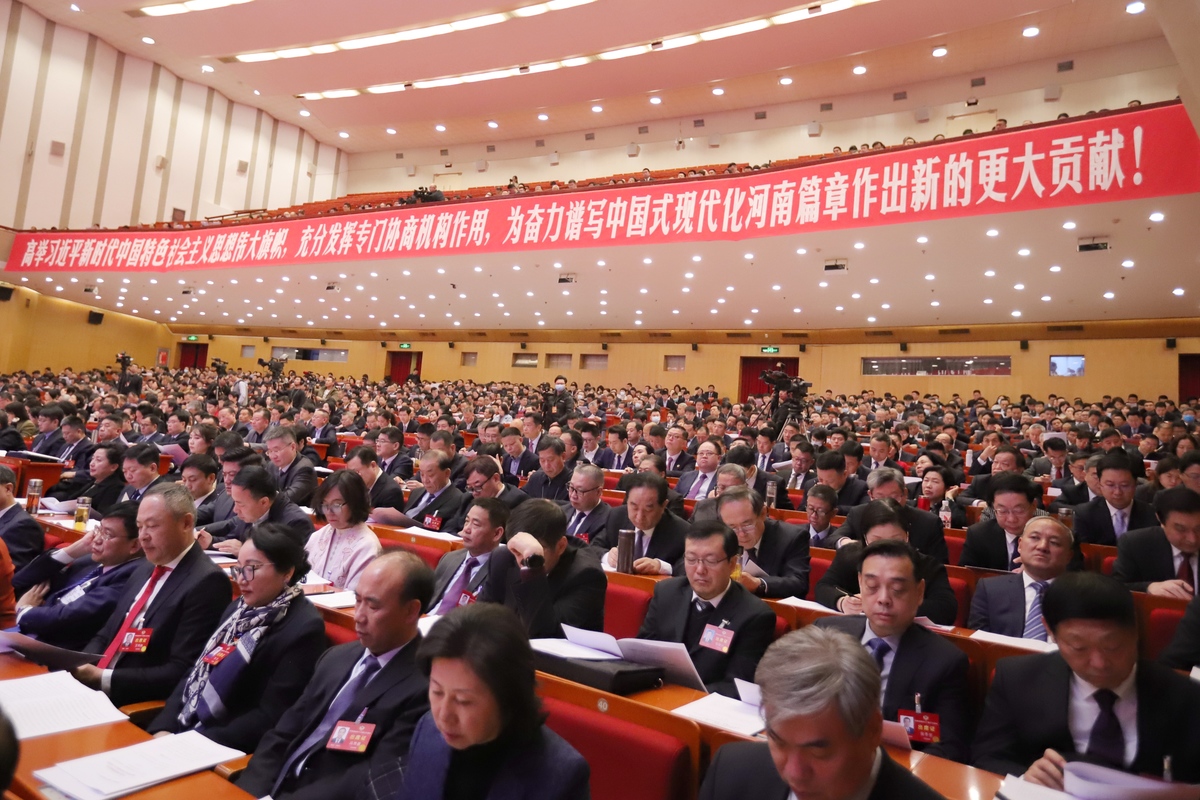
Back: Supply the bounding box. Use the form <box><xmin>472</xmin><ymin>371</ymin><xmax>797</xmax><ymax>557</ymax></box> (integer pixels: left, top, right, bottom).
<box><xmin>238</xmin><ymin>551</ymin><xmax>433</xmax><ymax>800</ymax></box>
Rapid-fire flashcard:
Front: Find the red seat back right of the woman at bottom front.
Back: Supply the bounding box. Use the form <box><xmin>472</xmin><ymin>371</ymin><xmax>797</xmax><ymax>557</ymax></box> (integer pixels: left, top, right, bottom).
<box><xmin>542</xmin><ymin>697</ymin><xmax>690</xmax><ymax>800</ymax></box>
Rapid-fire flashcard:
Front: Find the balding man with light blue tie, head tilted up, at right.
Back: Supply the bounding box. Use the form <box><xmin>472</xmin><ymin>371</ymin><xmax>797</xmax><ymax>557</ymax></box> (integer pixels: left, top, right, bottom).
<box><xmin>967</xmin><ymin>517</ymin><xmax>1075</xmax><ymax>642</ymax></box>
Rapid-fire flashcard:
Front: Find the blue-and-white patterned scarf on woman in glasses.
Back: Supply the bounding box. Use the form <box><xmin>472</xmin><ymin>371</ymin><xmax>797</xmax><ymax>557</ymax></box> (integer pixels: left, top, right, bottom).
<box><xmin>179</xmin><ymin>584</ymin><xmax>304</xmax><ymax>728</ymax></box>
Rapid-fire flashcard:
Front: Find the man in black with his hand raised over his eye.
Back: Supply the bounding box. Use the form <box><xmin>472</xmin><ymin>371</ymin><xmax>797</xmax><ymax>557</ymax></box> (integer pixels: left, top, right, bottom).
<box><xmin>479</xmin><ymin>501</ymin><xmax>608</xmax><ymax>639</ymax></box>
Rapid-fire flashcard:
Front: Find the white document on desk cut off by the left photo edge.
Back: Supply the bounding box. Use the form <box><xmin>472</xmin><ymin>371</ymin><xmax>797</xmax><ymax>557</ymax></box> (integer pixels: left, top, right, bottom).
<box><xmin>0</xmin><ymin>672</ymin><xmax>126</xmax><ymax>739</ymax></box>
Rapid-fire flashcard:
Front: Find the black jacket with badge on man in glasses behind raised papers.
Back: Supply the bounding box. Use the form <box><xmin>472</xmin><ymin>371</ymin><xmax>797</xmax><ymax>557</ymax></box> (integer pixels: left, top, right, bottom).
<box><xmin>637</xmin><ymin>577</ymin><xmax>775</xmax><ymax>697</ymax></box>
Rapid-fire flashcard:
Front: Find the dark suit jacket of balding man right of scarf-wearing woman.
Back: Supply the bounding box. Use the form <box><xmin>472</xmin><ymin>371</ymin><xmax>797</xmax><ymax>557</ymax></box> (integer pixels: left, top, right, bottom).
<box><xmin>238</xmin><ymin>634</ymin><xmax>430</xmax><ymax>800</ymax></box>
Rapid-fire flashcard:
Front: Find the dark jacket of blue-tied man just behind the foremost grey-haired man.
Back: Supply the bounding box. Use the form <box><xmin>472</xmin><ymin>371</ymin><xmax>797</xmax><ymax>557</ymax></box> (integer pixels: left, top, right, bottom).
<box><xmin>816</xmin><ymin>616</ymin><xmax>972</xmax><ymax>763</ymax></box>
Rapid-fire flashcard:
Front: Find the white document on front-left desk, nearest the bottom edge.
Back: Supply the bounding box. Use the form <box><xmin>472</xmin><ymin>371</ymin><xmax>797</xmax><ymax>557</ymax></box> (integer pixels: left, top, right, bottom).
<box><xmin>34</xmin><ymin>730</ymin><xmax>245</xmax><ymax>800</ymax></box>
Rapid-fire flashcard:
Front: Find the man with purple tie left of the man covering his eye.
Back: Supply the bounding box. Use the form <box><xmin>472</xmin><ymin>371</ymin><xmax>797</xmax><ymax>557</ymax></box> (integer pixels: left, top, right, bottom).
<box><xmin>430</xmin><ymin>498</ymin><xmax>511</xmax><ymax>615</ymax></box>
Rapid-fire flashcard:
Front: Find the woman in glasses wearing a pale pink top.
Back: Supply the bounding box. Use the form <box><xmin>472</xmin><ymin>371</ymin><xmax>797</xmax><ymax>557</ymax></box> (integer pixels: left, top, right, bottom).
<box><xmin>305</xmin><ymin>469</ymin><xmax>383</xmax><ymax>591</ymax></box>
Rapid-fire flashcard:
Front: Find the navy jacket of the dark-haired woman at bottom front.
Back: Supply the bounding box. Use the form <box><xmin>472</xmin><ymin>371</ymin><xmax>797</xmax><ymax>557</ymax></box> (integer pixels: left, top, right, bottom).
<box><xmin>393</xmin><ymin>714</ymin><xmax>589</xmax><ymax>800</ymax></box>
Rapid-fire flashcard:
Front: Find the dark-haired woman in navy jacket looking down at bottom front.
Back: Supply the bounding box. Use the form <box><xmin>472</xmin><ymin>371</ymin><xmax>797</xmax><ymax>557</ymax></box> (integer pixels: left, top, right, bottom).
<box><xmin>368</xmin><ymin>603</ymin><xmax>590</xmax><ymax>800</ymax></box>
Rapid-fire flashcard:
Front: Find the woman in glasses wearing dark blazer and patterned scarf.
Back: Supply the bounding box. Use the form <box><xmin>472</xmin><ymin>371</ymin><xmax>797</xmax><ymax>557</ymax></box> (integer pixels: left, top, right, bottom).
<box><xmin>146</xmin><ymin>523</ymin><xmax>326</xmax><ymax>753</ymax></box>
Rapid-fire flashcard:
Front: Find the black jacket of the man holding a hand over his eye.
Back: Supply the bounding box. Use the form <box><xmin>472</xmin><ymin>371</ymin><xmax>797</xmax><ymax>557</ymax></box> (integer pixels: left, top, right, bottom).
<box><xmin>480</xmin><ymin>537</ymin><xmax>608</xmax><ymax>639</ymax></box>
